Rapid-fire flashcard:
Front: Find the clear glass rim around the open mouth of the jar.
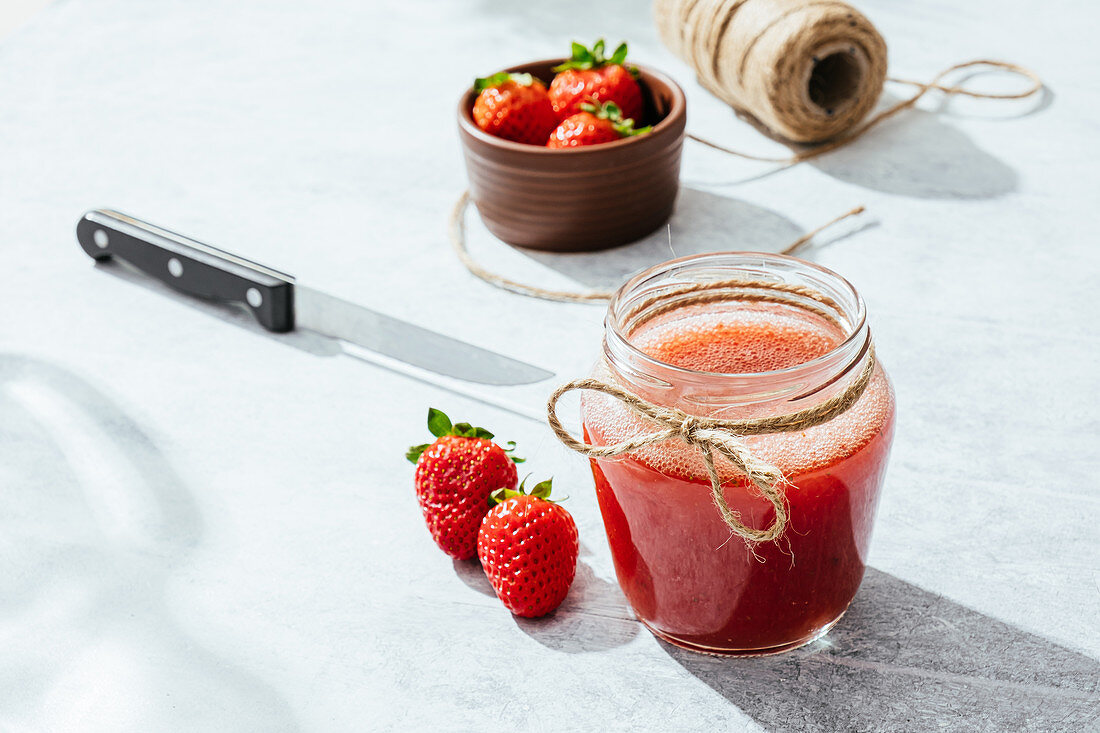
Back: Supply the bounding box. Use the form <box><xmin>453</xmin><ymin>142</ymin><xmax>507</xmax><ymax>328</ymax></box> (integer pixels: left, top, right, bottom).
<box><xmin>604</xmin><ymin>251</ymin><xmax>870</xmax><ymax>382</ymax></box>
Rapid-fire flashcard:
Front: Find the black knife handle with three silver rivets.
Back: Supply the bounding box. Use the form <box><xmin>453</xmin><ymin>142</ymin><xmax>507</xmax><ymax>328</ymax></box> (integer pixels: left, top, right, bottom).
<box><xmin>76</xmin><ymin>209</ymin><xmax>294</xmax><ymax>333</ymax></box>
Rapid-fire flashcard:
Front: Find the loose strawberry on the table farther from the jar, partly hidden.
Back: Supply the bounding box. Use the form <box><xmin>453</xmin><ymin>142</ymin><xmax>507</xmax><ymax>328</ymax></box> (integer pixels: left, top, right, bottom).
<box><xmin>405</xmin><ymin>408</ymin><xmax>524</xmax><ymax>560</ymax></box>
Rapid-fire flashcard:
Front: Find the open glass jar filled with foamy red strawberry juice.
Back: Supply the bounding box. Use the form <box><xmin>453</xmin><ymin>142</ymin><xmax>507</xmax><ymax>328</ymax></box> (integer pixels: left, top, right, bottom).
<box><xmin>581</xmin><ymin>253</ymin><xmax>894</xmax><ymax>654</ymax></box>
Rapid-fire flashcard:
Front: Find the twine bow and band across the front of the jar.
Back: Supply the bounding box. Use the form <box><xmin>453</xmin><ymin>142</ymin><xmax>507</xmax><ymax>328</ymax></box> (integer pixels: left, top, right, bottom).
<box><xmin>547</xmin><ymin>341</ymin><xmax>876</xmax><ymax>544</ymax></box>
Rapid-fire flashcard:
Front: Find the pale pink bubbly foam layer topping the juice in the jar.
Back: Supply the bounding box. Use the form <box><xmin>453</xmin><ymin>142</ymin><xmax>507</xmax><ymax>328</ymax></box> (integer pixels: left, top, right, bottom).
<box><xmin>583</xmin><ymin>304</ymin><xmax>892</xmax><ymax>481</ymax></box>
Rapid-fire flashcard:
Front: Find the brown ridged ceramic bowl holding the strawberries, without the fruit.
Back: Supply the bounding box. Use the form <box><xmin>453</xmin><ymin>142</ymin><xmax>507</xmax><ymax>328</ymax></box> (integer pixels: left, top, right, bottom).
<box><xmin>459</xmin><ymin>58</ymin><xmax>688</xmax><ymax>252</ymax></box>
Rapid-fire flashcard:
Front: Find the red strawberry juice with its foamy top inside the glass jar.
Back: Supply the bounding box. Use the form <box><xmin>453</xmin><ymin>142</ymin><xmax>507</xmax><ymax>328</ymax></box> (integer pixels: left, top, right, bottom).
<box><xmin>582</xmin><ymin>304</ymin><xmax>894</xmax><ymax>654</ymax></box>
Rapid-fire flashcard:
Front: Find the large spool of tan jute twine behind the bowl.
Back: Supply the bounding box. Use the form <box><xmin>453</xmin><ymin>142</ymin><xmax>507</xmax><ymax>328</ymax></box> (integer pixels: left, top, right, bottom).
<box><xmin>655</xmin><ymin>0</ymin><xmax>887</xmax><ymax>143</ymax></box>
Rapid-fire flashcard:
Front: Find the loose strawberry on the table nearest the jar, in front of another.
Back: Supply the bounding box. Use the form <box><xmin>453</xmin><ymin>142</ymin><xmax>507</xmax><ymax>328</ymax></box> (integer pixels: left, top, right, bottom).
<box><xmin>477</xmin><ymin>481</ymin><xmax>580</xmax><ymax>619</ymax></box>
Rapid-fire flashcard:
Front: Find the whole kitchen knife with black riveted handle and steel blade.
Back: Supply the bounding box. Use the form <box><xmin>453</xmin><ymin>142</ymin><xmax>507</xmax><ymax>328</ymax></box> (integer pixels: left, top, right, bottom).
<box><xmin>76</xmin><ymin>209</ymin><xmax>553</xmax><ymax>386</ymax></box>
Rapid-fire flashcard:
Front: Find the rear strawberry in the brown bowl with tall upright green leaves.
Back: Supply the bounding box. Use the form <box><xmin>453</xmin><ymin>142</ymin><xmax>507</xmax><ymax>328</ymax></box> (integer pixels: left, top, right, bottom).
<box><xmin>550</xmin><ymin>39</ymin><xmax>642</xmax><ymax>120</ymax></box>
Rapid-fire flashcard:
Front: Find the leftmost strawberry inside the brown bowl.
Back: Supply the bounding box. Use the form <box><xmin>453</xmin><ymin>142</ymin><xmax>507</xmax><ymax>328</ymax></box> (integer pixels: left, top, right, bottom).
<box><xmin>473</xmin><ymin>72</ymin><xmax>558</xmax><ymax>145</ymax></box>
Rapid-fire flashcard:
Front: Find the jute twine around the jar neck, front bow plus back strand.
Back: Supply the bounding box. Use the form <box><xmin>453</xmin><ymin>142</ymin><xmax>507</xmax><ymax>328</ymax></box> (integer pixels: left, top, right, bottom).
<box><xmin>547</xmin><ymin>280</ymin><xmax>876</xmax><ymax>546</ymax></box>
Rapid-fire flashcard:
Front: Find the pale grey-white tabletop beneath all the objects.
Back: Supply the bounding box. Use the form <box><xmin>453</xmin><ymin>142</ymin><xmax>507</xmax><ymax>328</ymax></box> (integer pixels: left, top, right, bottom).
<box><xmin>0</xmin><ymin>0</ymin><xmax>1100</xmax><ymax>731</ymax></box>
